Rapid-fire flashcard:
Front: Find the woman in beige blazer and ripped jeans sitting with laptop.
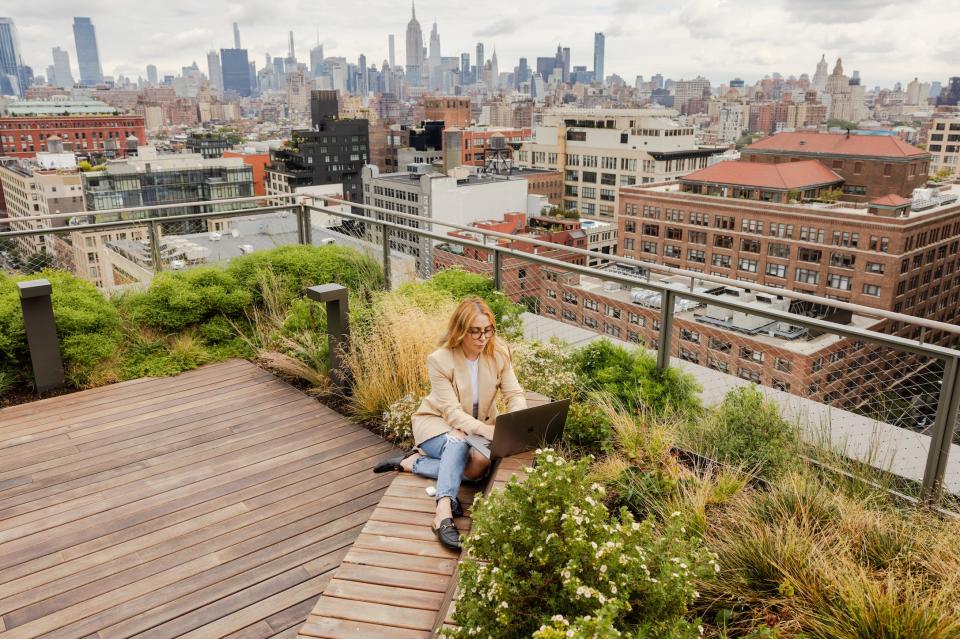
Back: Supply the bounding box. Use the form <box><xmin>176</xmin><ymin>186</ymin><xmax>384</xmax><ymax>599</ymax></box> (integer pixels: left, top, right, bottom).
<box><xmin>374</xmin><ymin>297</ymin><xmax>527</xmax><ymax>550</ymax></box>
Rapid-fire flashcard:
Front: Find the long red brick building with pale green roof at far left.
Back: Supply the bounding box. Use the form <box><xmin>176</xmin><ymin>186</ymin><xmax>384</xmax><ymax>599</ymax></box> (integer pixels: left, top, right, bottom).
<box><xmin>0</xmin><ymin>100</ymin><xmax>147</xmax><ymax>158</ymax></box>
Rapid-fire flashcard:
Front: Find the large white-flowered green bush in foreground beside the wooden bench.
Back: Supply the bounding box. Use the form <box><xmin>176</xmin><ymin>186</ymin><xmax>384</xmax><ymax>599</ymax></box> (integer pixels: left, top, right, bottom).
<box><xmin>452</xmin><ymin>450</ymin><xmax>719</xmax><ymax>639</ymax></box>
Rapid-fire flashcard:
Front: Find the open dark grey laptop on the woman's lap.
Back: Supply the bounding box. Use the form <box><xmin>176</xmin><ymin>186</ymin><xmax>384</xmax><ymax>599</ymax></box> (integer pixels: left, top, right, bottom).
<box><xmin>467</xmin><ymin>399</ymin><xmax>570</xmax><ymax>459</ymax></box>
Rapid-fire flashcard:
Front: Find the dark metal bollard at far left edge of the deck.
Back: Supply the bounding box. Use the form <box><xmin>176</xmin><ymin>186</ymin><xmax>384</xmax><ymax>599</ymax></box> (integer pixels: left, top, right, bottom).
<box><xmin>17</xmin><ymin>280</ymin><xmax>66</xmax><ymax>393</ymax></box>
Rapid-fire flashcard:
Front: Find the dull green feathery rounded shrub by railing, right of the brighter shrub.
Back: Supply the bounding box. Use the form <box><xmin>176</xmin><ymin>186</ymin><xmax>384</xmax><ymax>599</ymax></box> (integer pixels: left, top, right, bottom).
<box><xmin>687</xmin><ymin>386</ymin><xmax>800</xmax><ymax>479</ymax></box>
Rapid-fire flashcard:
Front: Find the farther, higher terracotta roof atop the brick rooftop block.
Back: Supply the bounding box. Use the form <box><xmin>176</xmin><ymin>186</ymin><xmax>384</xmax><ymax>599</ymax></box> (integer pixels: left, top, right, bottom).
<box><xmin>745</xmin><ymin>132</ymin><xmax>928</xmax><ymax>158</ymax></box>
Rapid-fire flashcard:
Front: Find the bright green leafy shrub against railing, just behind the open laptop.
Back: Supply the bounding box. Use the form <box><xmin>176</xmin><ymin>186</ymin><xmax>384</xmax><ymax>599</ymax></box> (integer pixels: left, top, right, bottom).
<box><xmin>573</xmin><ymin>339</ymin><xmax>700</xmax><ymax>416</ymax></box>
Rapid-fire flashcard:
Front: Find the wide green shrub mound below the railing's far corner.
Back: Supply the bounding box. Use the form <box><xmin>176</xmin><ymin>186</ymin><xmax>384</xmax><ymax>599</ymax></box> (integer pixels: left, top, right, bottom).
<box><xmin>227</xmin><ymin>244</ymin><xmax>384</xmax><ymax>304</ymax></box>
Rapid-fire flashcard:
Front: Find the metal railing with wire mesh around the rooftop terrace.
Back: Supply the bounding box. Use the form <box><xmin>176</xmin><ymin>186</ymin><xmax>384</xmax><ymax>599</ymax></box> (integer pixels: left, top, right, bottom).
<box><xmin>0</xmin><ymin>195</ymin><xmax>960</xmax><ymax>499</ymax></box>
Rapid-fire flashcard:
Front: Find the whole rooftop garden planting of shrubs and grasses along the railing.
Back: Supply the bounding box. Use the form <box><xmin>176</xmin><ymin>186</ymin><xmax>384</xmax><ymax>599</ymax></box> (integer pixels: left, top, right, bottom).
<box><xmin>0</xmin><ymin>246</ymin><xmax>960</xmax><ymax>639</ymax></box>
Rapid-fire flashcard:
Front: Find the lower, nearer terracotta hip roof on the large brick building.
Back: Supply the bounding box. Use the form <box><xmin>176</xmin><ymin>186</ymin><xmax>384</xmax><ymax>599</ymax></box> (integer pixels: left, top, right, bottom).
<box><xmin>680</xmin><ymin>160</ymin><xmax>843</xmax><ymax>191</ymax></box>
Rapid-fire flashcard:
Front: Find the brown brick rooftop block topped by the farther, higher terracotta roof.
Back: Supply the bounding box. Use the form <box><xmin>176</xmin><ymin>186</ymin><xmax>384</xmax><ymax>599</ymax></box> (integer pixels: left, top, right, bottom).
<box><xmin>741</xmin><ymin>131</ymin><xmax>930</xmax><ymax>202</ymax></box>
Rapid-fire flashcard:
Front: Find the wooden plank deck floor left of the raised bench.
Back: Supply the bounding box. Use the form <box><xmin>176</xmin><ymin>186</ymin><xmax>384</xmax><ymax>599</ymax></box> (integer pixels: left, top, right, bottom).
<box><xmin>0</xmin><ymin>360</ymin><xmax>398</xmax><ymax>639</ymax></box>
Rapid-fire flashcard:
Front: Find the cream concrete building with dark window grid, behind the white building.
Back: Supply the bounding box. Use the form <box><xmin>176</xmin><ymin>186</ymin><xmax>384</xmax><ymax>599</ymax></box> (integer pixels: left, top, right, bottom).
<box><xmin>517</xmin><ymin>109</ymin><xmax>723</xmax><ymax>226</ymax></box>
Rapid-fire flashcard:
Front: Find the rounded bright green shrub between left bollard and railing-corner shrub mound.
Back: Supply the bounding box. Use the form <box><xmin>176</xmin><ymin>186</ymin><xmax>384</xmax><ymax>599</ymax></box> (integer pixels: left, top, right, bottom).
<box><xmin>121</xmin><ymin>267</ymin><xmax>253</xmax><ymax>332</ymax></box>
